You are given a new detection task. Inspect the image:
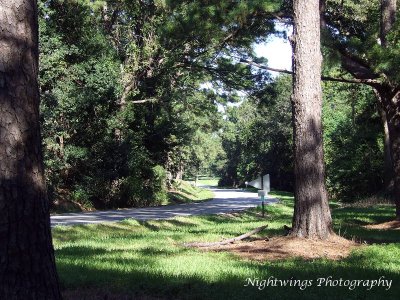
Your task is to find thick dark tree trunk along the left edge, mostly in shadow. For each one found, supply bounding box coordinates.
[0,0,61,299]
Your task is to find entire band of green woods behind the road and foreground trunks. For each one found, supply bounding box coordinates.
[39,0,399,211]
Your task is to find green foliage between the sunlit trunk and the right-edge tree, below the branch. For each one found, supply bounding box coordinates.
[323,83,383,201]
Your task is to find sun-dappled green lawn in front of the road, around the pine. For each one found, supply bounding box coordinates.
[53,193,400,300]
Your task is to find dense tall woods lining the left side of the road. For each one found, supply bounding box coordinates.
[40,0,278,207]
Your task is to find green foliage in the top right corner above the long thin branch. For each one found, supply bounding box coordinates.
[324,0,400,84]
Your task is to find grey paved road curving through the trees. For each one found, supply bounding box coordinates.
[51,188,277,226]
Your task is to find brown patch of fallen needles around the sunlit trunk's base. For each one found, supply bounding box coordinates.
[207,236,361,261]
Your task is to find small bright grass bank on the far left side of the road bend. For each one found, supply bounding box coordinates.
[163,180,214,205]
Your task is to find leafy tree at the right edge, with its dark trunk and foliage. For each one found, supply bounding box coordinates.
[323,0,400,218]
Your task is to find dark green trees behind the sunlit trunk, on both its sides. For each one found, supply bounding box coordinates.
[221,75,385,201]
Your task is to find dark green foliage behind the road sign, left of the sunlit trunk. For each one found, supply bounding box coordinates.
[220,76,293,190]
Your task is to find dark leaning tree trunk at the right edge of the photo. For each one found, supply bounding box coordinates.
[376,86,400,220]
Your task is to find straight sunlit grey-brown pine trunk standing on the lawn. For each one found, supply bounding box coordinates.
[292,0,332,239]
